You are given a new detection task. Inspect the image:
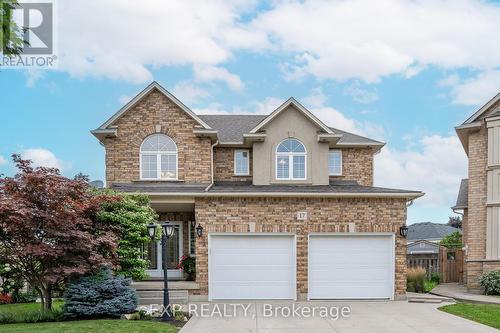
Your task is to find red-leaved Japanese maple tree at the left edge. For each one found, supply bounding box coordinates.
[0,155,119,309]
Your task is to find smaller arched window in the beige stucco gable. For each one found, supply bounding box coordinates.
[276,139,307,180]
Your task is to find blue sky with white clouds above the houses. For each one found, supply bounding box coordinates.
[0,0,500,224]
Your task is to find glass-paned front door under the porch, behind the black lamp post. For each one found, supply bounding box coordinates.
[147,222,183,280]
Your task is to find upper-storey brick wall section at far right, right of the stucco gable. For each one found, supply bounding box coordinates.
[330,148,374,186]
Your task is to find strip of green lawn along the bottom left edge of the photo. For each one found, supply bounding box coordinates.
[0,320,178,333]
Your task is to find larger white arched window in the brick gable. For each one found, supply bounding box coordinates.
[141,134,177,180]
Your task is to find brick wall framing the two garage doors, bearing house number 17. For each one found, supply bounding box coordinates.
[195,198,406,295]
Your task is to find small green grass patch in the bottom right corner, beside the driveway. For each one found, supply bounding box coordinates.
[439,303,500,329]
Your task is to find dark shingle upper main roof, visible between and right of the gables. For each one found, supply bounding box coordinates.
[199,115,382,144]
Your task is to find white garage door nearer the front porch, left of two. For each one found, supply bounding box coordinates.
[208,234,296,300]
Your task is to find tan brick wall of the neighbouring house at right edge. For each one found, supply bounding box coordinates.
[463,121,500,289]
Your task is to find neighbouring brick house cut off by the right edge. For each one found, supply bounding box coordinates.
[452,93,500,289]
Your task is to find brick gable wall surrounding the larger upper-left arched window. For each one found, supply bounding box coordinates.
[104,90,211,186]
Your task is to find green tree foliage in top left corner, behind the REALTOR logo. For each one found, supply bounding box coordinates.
[0,0,28,56]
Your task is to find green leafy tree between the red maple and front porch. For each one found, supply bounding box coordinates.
[92,189,158,281]
